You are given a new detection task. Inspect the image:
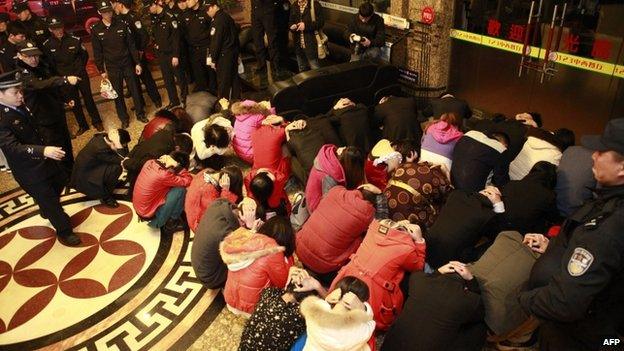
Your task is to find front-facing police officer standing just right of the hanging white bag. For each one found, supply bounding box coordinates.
[91,0,148,128]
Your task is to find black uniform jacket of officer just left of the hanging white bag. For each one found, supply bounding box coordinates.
[43,34,89,76]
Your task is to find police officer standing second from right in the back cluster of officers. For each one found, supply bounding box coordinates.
[180,0,217,93]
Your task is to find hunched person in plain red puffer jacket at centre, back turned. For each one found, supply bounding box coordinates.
[296,185,379,280]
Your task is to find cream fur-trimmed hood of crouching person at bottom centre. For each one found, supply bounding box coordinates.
[300,296,375,351]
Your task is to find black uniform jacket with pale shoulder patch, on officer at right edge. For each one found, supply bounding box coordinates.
[519,186,624,348]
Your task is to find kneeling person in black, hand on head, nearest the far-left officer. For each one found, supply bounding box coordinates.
[70,129,130,208]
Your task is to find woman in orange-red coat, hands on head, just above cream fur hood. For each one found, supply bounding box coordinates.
[332,219,426,330]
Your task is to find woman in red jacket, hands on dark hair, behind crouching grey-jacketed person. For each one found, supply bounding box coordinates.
[184,166,243,232]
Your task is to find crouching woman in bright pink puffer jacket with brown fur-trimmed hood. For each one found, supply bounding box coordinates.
[230,100,275,163]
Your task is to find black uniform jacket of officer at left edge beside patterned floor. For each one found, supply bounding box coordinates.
[0,105,57,184]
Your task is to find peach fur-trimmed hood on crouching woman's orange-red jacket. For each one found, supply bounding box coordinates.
[219,227,286,271]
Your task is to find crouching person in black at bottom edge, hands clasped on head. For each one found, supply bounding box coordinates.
[380,261,487,351]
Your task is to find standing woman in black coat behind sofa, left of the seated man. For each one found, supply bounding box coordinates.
[288,0,324,72]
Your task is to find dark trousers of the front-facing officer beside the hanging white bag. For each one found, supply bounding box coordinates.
[106,64,145,122]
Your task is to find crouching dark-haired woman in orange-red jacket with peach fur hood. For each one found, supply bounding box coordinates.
[219,216,295,317]
